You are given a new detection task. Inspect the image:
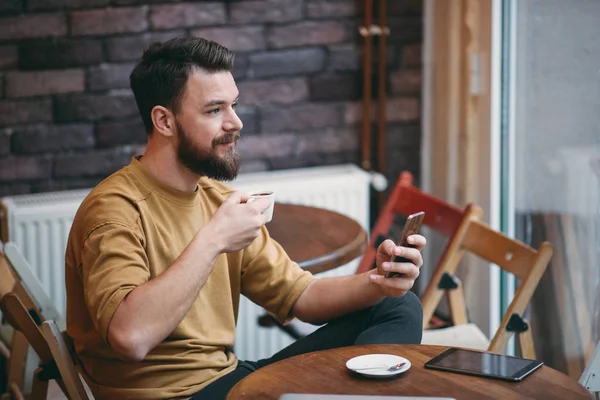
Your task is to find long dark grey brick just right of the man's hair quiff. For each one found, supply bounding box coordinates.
[248,47,326,78]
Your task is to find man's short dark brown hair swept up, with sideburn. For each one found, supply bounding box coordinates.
[129,37,234,134]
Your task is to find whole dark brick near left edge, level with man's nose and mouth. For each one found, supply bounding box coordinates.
[12,124,94,154]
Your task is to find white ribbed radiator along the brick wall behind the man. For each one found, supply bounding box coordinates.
[0,165,371,360]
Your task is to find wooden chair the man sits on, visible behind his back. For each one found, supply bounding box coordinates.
[0,293,90,400]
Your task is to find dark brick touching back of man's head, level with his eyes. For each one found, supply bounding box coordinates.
[55,91,138,122]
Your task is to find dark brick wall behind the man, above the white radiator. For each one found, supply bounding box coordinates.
[0,0,422,196]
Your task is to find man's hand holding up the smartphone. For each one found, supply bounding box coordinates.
[370,235,427,297]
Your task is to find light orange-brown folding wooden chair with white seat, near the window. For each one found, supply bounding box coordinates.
[422,219,553,359]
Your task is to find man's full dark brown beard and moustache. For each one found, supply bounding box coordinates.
[175,122,240,181]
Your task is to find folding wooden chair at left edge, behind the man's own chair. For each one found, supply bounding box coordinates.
[0,242,59,398]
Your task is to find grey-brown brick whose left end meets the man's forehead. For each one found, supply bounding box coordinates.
[238,78,308,106]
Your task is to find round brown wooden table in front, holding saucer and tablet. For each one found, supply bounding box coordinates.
[227,345,592,400]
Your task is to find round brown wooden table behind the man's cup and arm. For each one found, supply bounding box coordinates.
[267,203,367,274]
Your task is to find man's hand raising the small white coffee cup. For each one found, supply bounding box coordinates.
[207,192,271,253]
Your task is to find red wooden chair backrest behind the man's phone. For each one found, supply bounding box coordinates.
[357,171,474,276]
